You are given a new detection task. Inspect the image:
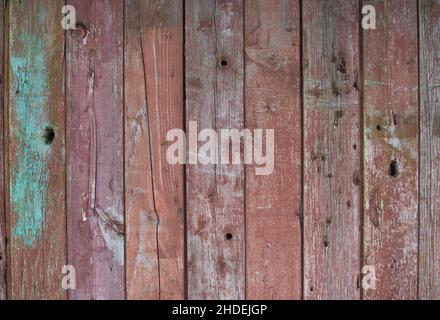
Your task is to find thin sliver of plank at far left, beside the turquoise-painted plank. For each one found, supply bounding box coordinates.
[0,0,7,300]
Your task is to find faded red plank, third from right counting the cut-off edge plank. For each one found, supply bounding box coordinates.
[303,0,361,300]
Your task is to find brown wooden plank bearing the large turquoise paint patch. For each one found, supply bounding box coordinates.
[7,0,66,299]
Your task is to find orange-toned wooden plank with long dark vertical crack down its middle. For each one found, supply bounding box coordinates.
[125,0,185,299]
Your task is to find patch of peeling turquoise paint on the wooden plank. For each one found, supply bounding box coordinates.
[10,34,50,247]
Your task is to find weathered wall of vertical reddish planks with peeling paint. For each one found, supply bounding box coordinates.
[0,0,440,300]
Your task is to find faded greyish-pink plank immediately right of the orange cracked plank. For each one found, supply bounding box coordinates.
[185,0,245,299]
